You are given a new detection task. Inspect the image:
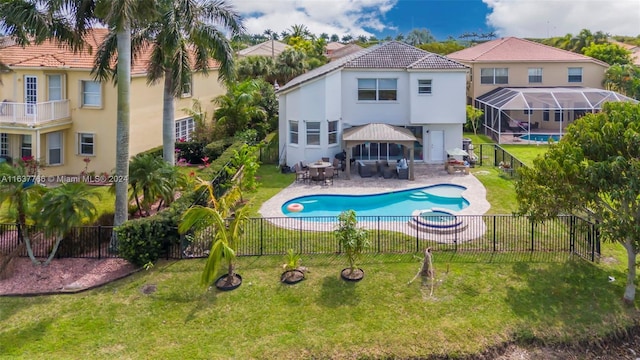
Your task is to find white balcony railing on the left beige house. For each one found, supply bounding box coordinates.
[0,100,70,126]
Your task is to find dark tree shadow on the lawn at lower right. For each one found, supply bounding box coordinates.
[506,259,628,342]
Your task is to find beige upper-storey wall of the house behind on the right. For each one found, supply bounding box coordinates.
[458,60,607,103]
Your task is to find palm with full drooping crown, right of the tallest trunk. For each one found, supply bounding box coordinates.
[94,0,244,165]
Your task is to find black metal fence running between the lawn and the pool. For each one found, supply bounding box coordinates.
[0,215,600,261]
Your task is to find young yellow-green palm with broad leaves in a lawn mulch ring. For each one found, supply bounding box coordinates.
[178,179,247,286]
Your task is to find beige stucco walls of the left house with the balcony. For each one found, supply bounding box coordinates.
[0,69,225,175]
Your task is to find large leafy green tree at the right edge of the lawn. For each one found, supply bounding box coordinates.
[516,102,640,302]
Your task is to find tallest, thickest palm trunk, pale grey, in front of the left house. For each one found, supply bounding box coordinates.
[109,24,131,250]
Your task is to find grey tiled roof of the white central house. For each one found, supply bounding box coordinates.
[278,41,467,93]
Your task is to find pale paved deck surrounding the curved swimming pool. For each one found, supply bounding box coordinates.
[259,164,491,242]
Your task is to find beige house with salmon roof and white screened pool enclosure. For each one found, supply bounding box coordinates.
[447,37,633,142]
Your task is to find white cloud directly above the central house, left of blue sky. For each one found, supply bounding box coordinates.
[233,0,398,36]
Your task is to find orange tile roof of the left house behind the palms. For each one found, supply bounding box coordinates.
[0,28,215,75]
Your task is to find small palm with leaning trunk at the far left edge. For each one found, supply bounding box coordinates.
[0,160,44,264]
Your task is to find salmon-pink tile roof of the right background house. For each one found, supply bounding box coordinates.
[447,37,609,67]
